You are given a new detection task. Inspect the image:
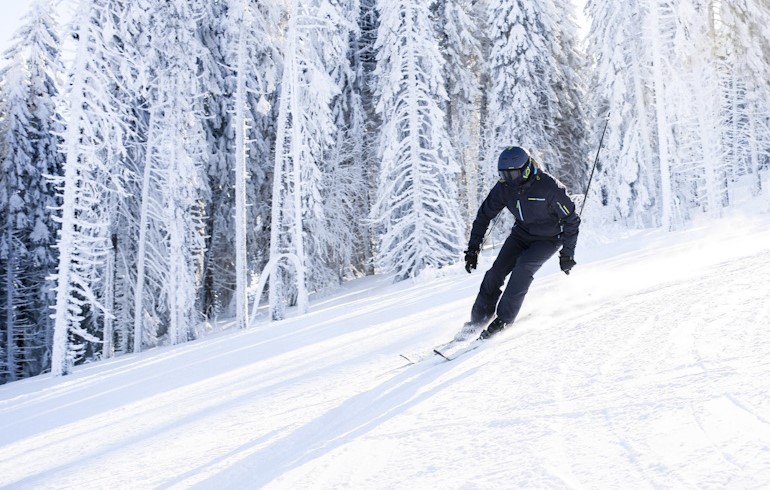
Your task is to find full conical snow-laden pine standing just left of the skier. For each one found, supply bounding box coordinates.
[371,0,463,280]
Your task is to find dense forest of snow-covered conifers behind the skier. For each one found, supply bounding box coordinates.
[0,0,770,383]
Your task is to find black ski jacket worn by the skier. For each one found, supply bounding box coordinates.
[468,167,580,257]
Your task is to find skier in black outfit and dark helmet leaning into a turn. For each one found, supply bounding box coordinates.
[455,146,580,341]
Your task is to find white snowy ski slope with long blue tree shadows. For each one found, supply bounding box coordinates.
[0,205,770,489]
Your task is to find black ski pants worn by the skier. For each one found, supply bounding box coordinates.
[471,227,561,324]
